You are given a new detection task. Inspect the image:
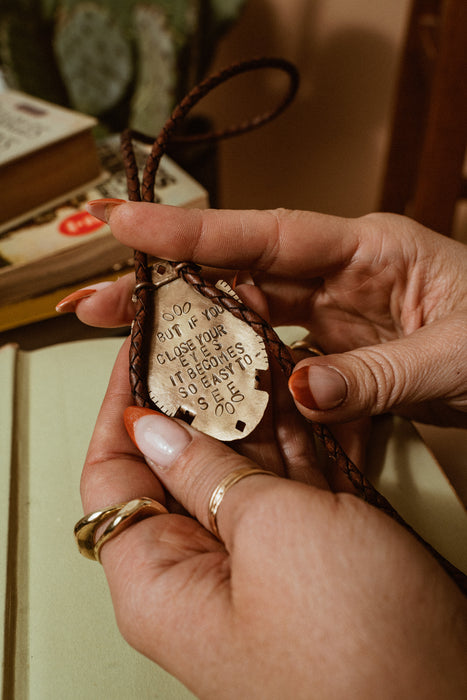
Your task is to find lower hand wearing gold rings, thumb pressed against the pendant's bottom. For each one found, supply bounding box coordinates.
[82,343,467,700]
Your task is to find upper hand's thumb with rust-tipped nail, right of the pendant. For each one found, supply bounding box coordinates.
[289,319,467,422]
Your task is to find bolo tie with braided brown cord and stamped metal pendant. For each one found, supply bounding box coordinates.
[121,58,467,594]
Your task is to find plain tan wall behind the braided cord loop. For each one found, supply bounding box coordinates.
[201,0,409,216]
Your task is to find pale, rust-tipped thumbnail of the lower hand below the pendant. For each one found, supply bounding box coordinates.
[123,406,191,471]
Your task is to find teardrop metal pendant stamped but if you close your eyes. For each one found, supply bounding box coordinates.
[147,260,269,441]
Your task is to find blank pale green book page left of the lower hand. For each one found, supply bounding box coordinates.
[15,338,192,700]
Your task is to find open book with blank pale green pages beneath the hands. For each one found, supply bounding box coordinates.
[0,338,467,700]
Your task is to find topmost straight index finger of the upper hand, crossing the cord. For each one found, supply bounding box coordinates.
[86,199,359,278]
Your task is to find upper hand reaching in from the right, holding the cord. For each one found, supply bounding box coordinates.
[78,200,467,426]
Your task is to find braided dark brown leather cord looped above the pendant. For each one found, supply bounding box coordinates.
[121,58,467,594]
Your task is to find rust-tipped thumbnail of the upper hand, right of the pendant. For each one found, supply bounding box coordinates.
[289,365,347,411]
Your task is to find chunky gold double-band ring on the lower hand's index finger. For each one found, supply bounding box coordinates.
[74,497,169,562]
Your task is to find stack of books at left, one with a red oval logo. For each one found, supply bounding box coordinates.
[0,91,208,331]
